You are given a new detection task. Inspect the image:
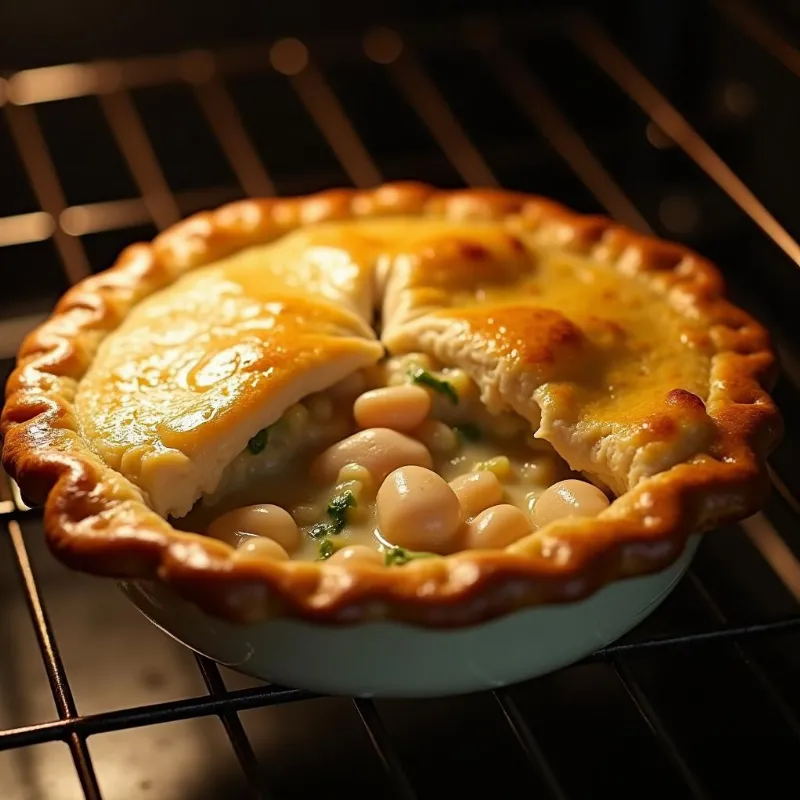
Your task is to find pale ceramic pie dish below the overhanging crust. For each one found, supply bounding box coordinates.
[120,536,700,697]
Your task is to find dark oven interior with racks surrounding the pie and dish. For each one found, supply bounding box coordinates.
[0,0,800,800]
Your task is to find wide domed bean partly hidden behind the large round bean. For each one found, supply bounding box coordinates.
[311,428,433,484]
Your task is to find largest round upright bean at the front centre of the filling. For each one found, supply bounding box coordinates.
[376,466,464,553]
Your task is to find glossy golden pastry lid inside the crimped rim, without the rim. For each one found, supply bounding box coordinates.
[75,215,714,517]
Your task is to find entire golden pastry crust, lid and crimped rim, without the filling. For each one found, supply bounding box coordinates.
[2,184,780,626]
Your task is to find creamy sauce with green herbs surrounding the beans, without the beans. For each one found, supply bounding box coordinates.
[181,354,575,560]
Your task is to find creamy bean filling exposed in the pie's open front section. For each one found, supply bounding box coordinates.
[179,354,609,566]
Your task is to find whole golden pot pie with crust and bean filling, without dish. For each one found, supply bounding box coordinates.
[2,184,780,626]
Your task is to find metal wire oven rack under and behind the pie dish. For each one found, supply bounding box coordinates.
[0,0,800,800]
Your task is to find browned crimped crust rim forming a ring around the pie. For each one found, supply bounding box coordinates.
[0,183,782,627]
